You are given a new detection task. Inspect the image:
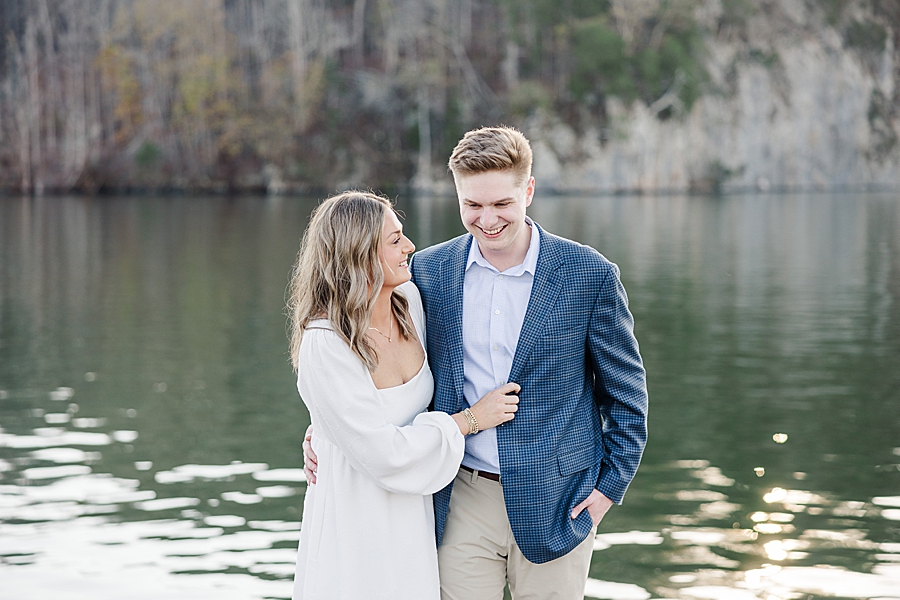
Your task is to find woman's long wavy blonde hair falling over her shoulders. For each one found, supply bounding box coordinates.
[287,190,416,372]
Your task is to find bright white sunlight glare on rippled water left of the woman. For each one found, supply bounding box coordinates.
[0,454,299,599]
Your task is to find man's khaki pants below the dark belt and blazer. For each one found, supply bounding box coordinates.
[438,469,594,600]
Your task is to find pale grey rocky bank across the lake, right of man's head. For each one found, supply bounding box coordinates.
[524,0,900,193]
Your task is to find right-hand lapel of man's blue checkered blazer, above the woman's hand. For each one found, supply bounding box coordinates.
[509,227,562,381]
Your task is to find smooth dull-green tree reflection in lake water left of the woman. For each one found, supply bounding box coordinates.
[0,198,311,478]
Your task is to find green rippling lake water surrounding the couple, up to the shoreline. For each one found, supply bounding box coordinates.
[0,194,900,600]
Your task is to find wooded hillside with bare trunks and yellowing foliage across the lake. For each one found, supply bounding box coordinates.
[0,0,880,193]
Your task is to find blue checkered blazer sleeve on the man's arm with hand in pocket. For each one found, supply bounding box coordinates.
[587,263,648,504]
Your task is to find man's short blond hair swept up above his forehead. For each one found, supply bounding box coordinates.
[448,125,531,185]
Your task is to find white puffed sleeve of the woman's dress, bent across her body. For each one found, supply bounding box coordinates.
[297,329,465,494]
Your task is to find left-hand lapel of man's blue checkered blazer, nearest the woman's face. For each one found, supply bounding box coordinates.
[440,235,472,410]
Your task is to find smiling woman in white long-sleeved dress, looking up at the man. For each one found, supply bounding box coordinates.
[289,191,518,600]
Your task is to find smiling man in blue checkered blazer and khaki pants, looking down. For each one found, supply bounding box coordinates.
[304,127,647,600]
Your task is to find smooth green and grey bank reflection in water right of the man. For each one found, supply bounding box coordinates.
[568,195,900,498]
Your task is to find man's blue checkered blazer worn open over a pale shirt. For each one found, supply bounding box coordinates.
[412,223,647,563]
